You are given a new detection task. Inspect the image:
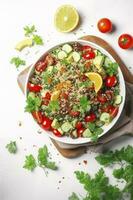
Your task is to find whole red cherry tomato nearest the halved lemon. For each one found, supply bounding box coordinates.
[97,18,112,33]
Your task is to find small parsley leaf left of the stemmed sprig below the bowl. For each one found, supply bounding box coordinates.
[23,154,37,171]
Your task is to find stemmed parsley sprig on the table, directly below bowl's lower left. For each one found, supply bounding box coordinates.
[38,145,57,170]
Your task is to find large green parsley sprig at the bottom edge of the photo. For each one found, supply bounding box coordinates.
[73,168,122,200]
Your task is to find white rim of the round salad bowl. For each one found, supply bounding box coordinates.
[24,39,126,145]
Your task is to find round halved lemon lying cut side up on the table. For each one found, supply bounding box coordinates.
[54,5,79,32]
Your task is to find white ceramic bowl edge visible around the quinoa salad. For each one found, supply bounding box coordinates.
[25,40,125,145]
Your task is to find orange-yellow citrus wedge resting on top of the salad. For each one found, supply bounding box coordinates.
[85,72,103,93]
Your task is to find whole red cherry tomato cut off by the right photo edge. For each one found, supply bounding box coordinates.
[118,34,133,49]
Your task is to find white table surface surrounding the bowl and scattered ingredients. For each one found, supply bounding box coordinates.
[0,0,133,200]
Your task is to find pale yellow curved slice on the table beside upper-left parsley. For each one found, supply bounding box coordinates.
[15,38,33,51]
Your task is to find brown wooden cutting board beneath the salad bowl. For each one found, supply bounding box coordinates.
[18,35,133,158]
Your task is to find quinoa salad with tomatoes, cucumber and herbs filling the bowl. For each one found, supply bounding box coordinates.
[25,42,122,141]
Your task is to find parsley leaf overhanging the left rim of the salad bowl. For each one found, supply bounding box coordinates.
[25,96,41,112]
